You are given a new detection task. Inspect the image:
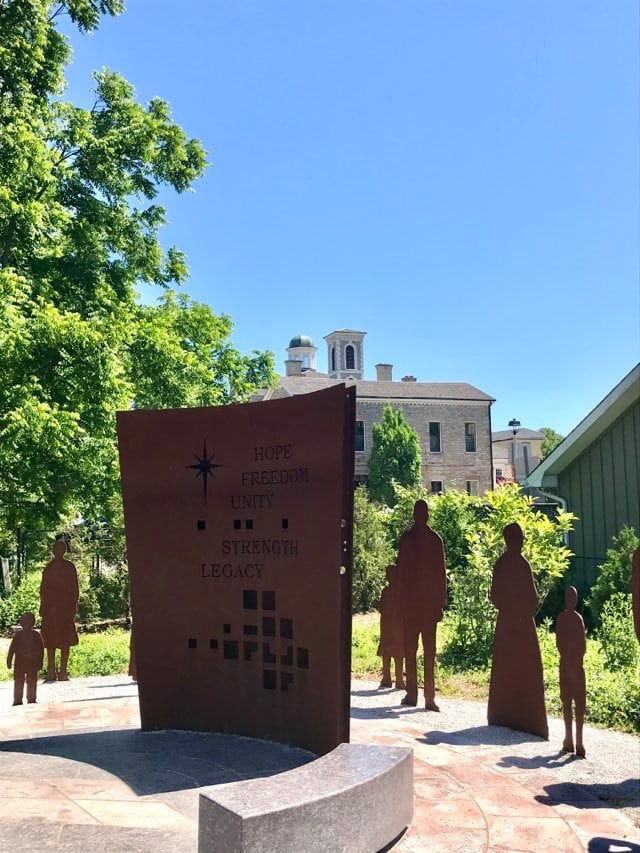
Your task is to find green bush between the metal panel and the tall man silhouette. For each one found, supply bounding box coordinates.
[353,486,393,613]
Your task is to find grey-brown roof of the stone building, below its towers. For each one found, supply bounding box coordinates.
[260,373,494,403]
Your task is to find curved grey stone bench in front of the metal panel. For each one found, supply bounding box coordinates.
[198,743,413,853]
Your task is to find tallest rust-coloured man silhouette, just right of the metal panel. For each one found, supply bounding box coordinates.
[397,500,447,711]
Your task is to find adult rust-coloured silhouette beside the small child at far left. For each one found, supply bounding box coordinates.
[40,539,80,681]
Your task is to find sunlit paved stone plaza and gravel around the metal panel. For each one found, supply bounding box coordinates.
[0,676,640,853]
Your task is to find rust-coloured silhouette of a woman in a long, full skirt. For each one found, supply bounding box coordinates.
[487,523,549,739]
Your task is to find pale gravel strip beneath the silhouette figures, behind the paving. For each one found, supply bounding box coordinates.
[0,675,640,825]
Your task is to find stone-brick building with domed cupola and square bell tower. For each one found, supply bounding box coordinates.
[254,329,494,494]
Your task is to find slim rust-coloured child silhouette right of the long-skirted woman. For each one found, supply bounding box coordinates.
[556,586,587,758]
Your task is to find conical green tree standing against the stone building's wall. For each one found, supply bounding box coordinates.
[369,403,422,506]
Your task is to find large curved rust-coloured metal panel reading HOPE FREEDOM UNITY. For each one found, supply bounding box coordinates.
[118,385,355,754]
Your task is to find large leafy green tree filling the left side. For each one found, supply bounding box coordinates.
[0,0,273,553]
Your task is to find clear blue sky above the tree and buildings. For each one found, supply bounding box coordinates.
[61,0,640,433]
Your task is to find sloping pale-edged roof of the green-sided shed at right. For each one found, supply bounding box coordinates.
[526,364,640,488]
